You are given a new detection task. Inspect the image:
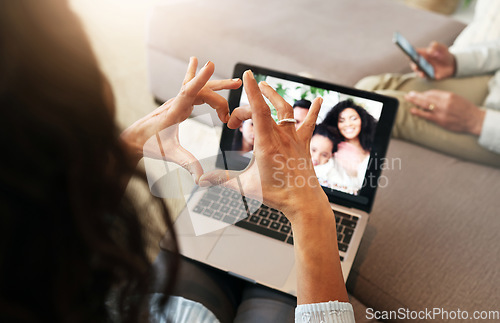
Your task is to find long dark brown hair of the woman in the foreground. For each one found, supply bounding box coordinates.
[0,0,177,322]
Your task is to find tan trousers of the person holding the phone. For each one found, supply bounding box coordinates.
[355,73,500,167]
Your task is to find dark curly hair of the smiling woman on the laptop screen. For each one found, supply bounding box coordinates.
[321,99,377,151]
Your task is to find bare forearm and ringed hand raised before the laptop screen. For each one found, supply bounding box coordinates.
[200,71,352,308]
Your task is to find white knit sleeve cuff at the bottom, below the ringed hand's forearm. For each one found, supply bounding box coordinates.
[295,301,354,323]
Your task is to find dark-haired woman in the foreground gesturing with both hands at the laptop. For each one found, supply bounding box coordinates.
[0,0,353,323]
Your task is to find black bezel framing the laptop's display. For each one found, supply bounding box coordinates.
[216,63,398,213]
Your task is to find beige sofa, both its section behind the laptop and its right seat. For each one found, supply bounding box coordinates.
[147,0,500,322]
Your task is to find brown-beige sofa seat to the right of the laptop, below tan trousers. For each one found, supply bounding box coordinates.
[347,140,500,322]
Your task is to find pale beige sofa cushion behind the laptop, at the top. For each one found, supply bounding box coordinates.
[147,0,464,100]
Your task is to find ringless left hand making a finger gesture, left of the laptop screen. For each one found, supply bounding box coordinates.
[121,57,241,182]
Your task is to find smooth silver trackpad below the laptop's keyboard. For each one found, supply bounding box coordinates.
[208,226,295,288]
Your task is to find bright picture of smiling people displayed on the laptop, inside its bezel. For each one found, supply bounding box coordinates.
[231,74,383,195]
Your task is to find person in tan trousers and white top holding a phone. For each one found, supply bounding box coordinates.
[355,6,500,167]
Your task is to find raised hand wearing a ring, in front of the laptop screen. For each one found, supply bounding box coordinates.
[200,71,327,222]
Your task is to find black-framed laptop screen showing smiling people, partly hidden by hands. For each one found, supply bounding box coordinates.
[217,64,397,212]
